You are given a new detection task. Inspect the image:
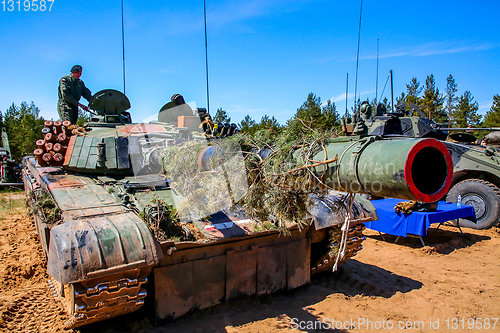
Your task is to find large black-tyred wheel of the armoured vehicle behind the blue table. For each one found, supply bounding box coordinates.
[446,179,500,229]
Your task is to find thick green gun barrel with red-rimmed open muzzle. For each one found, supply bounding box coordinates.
[198,137,453,202]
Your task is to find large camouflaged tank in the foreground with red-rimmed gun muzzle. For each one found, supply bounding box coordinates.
[23,90,451,327]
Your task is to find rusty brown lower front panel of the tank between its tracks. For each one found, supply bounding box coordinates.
[154,224,310,322]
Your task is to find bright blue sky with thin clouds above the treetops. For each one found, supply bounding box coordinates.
[0,0,500,124]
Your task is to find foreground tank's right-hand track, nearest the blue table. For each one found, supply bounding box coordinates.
[311,224,366,274]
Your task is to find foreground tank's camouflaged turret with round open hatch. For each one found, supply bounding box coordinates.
[51,89,224,176]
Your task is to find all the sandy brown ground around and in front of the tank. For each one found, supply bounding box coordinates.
[0,195,500,333]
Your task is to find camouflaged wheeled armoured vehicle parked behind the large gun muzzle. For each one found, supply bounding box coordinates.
[343,102,500,229]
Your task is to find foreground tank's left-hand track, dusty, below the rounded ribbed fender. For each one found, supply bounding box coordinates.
[49,270,148,329]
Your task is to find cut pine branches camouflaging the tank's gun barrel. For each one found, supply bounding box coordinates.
[160,120,344,233]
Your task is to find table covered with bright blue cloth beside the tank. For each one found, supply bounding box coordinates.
[365,199,476,243]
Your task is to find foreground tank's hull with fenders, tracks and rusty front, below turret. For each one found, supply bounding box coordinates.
[23,158,377,328]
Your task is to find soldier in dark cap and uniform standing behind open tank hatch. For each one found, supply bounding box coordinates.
[57,65,92,124]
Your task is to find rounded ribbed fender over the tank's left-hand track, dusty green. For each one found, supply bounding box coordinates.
[47,212,163,284]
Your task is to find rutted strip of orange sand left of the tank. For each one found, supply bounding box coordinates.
[0,193,70,332]
